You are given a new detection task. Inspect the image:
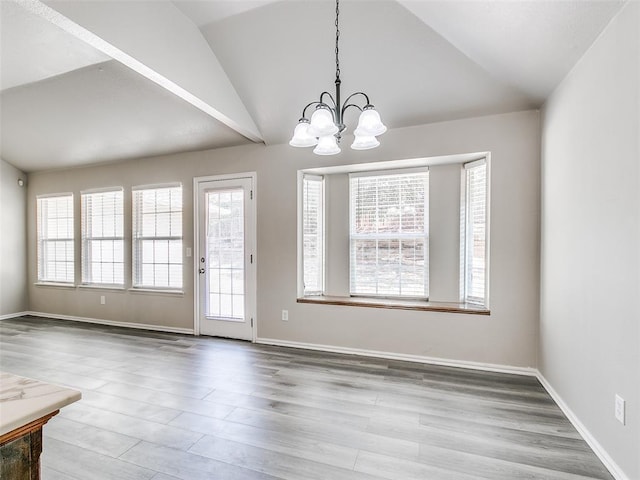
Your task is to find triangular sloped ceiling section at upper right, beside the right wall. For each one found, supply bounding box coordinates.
[400,0,623,103]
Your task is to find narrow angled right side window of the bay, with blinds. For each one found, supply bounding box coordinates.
[460,159,488,305]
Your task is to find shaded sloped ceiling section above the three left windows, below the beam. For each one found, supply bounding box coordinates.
[1,60,248,171]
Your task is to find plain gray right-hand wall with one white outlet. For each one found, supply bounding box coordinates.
[539,2,640,479]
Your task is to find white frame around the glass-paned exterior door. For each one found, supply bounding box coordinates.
[193,172,258,343]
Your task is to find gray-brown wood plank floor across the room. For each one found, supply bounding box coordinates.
[0,317,613,480]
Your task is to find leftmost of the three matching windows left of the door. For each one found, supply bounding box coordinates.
[36,193,74,283]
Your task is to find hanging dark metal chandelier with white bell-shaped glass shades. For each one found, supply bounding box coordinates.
[289,0,387,155]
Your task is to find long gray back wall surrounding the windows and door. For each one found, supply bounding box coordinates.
[28,111,540,367]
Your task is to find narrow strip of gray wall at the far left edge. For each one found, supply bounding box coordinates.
[0,159,28,317]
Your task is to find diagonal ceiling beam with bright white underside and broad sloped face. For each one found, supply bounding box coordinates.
[14,0,263,142]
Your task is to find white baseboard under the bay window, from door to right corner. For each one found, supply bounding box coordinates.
[256,338,538,376]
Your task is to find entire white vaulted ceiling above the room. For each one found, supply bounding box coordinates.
[0,0,623,171]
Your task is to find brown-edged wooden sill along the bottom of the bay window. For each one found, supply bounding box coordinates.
[297,295,491,315]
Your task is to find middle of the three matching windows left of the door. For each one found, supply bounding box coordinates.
[81,189,124,285]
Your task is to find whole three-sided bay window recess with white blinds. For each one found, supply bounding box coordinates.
[296,158,491,315]
